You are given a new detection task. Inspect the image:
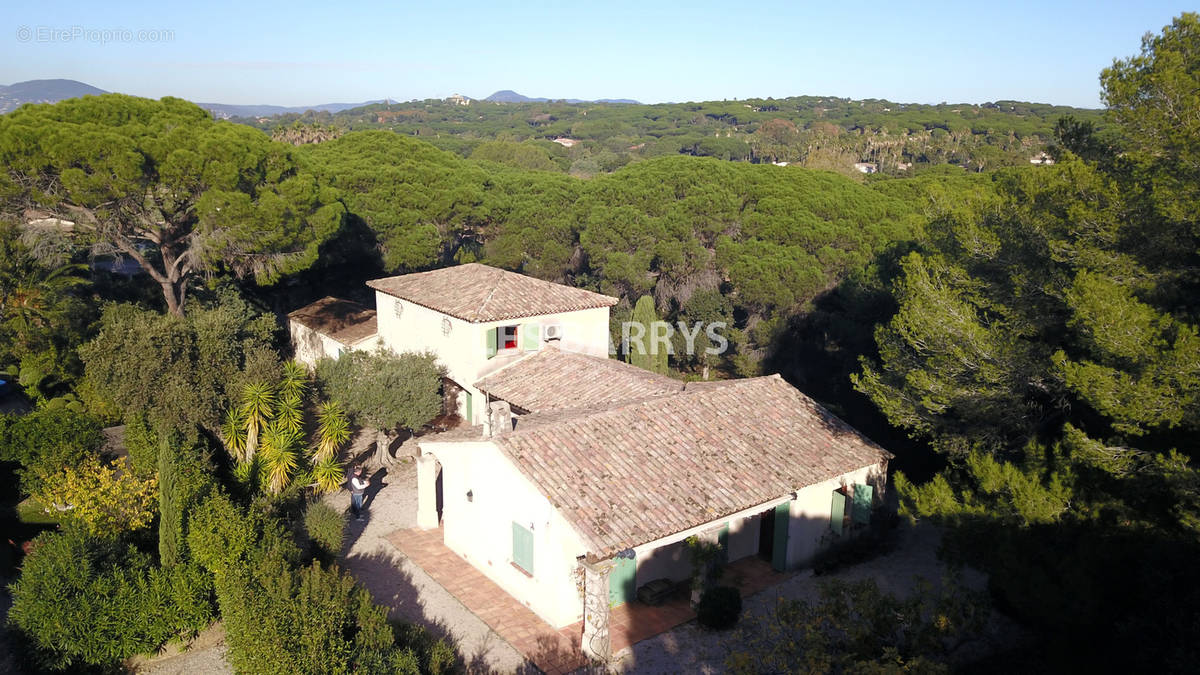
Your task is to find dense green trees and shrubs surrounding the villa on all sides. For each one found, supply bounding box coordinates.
[0,13,1200,673]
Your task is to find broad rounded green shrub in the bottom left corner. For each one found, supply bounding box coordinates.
[8,528,212,670]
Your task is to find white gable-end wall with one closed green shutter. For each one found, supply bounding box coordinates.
[421,441,584,627]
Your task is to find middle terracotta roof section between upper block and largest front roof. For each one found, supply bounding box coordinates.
[475,344,683,412]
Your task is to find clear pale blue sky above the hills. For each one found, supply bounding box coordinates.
[0,0,1188,107]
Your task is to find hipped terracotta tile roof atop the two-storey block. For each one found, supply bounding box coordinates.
[367,263,617,323]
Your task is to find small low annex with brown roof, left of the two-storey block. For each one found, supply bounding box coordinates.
[288,297,377,368]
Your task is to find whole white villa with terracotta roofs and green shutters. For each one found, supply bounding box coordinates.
[293,264,892,658]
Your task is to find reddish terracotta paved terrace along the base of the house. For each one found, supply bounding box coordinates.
[386,527,790,675]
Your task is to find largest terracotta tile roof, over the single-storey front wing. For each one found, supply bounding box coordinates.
[482,375,892,558]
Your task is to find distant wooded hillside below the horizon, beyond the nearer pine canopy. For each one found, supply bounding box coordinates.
[234,96,1104,177]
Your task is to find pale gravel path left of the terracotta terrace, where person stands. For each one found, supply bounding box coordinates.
[326,450,526,673]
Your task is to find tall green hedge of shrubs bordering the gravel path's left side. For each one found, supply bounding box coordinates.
[187,494,456,674]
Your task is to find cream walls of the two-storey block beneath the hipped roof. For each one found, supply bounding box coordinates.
[376,291,608,424]
